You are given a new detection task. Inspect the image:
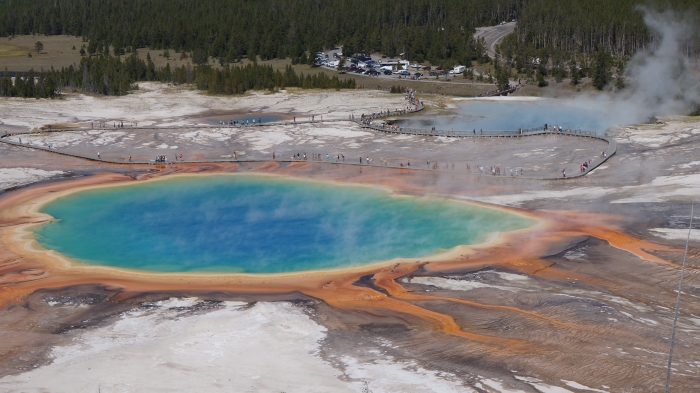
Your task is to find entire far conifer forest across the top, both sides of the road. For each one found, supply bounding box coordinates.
[0,0,700,64]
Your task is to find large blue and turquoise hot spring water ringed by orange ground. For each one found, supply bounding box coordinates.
[36,175,532,273]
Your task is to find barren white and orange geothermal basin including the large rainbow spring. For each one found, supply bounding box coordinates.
[0,49,700,393]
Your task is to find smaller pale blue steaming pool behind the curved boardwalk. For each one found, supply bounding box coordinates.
[409,99,615,133]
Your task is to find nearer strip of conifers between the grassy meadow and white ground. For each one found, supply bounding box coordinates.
[0,52,356,98]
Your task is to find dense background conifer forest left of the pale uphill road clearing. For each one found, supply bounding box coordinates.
[0,0,523,64]
